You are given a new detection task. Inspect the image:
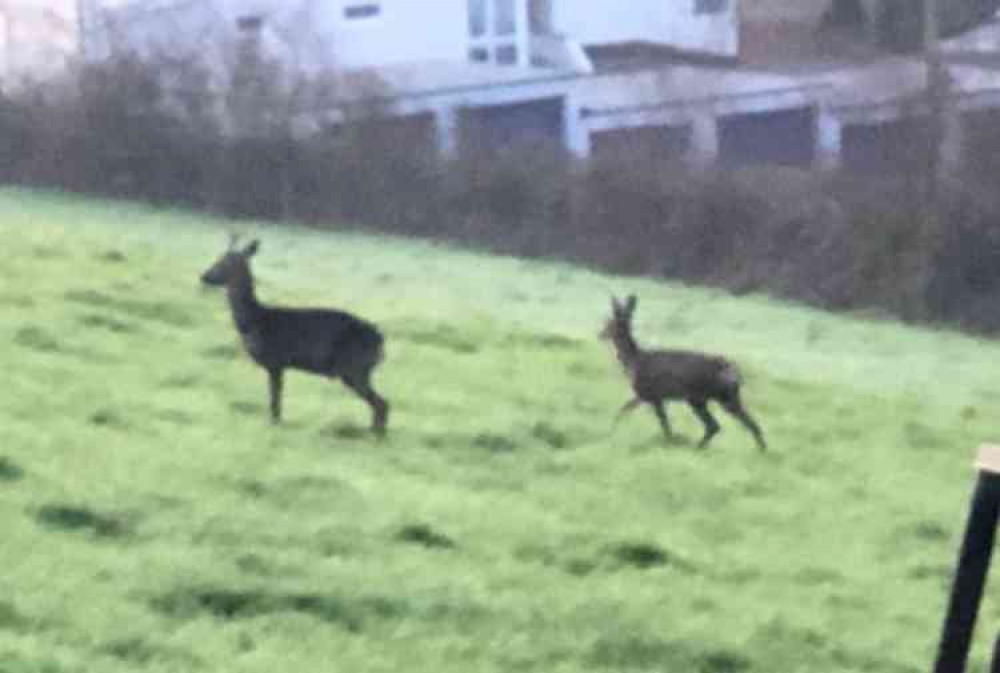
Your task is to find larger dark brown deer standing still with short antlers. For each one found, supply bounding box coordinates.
[201,237,389,436]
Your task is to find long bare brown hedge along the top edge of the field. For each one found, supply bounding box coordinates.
[0,28,1000,332]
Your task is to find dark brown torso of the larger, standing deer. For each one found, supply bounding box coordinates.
[241,307,383,376]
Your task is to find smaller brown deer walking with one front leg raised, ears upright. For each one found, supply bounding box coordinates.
[601,295,767,451]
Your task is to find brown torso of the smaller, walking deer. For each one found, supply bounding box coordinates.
[632,350,740,400]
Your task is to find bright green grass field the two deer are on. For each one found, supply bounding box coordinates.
[0,185,1000,673]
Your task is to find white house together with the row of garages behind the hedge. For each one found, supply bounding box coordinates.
[87,0,1000,173]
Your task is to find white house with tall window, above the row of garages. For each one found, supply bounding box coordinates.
[92,0,739,71]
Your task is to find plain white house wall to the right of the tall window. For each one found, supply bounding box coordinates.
[552,0,739,56]
